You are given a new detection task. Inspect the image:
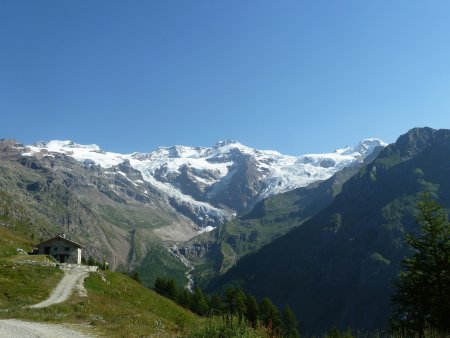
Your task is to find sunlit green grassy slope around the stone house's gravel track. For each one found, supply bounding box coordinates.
[0,228,200,337]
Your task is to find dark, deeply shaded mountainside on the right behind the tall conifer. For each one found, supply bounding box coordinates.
[210,128,450,333]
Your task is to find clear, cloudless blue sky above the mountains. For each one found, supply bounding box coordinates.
[0,0,450,155]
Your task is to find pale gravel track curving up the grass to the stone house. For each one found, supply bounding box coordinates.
[29,271,88,308]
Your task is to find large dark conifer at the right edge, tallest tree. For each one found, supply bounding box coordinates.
[391,194,450,334]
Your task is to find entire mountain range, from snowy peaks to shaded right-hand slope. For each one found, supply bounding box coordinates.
[0,128,450,334]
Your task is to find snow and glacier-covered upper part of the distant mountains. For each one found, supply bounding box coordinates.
[22,138,386,227]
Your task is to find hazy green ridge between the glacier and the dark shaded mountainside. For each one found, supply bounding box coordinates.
[187,164,358,285]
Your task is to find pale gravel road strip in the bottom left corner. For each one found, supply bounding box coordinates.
[0,319,89,338]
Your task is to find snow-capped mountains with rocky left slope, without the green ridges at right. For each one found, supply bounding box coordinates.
[0,139,384,285]
